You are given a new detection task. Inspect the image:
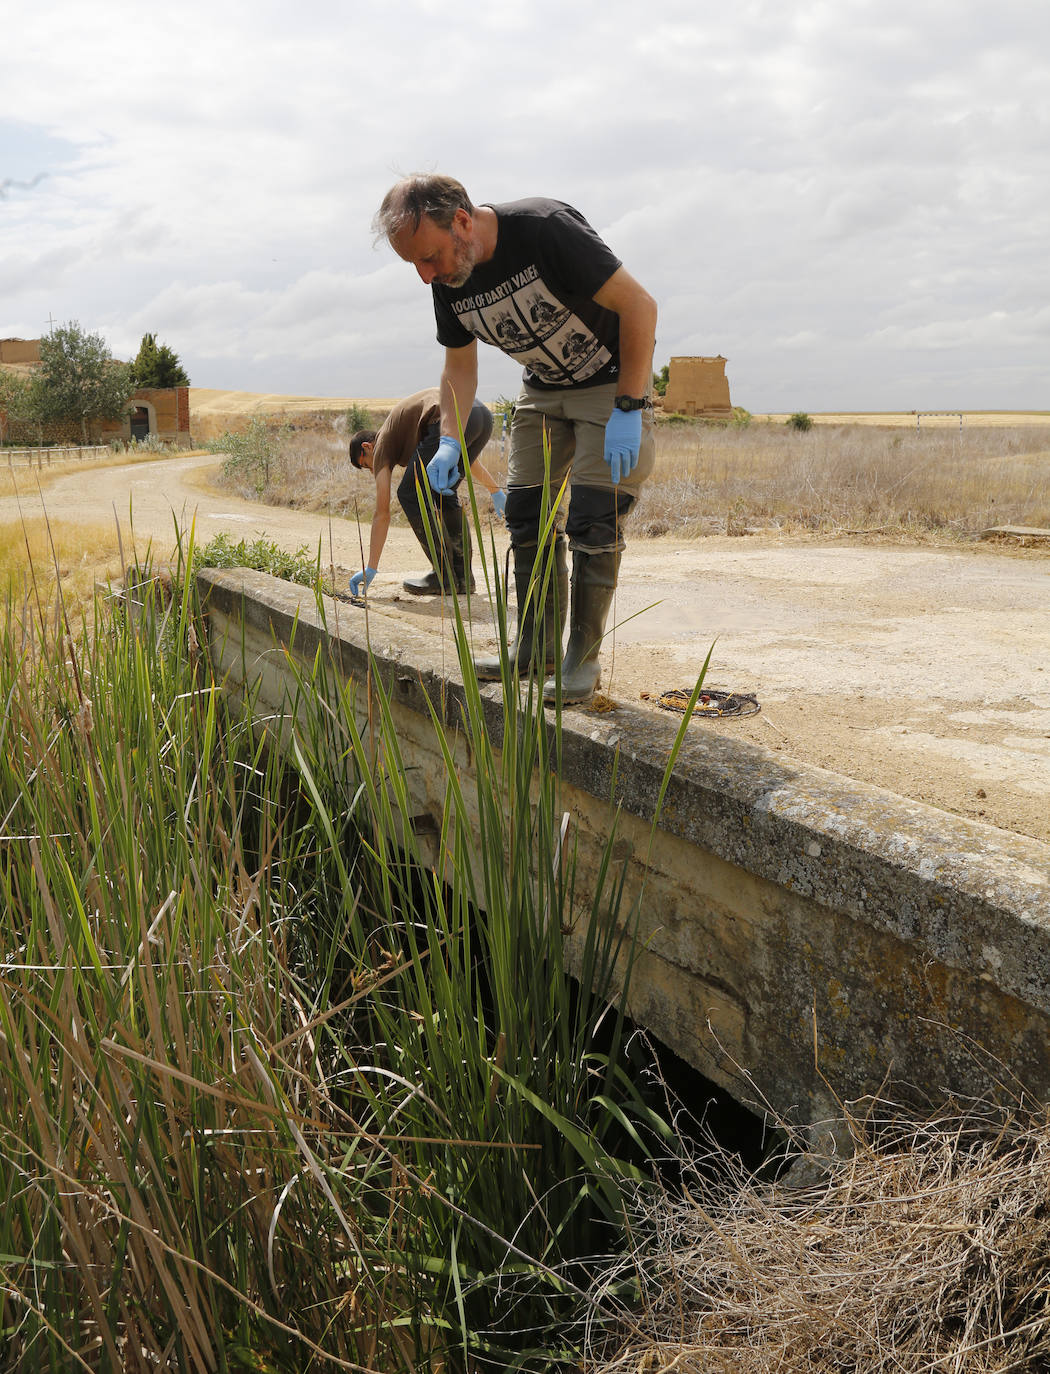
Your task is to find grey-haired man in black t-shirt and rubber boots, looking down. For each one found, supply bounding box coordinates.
[374,176,657,702]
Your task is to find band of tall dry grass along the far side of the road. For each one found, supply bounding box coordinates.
[211,416,1050,543]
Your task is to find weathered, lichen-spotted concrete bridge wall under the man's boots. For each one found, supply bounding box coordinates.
[201,570,1050,1121]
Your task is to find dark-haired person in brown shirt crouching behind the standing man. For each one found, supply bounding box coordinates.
[350,387,506,596]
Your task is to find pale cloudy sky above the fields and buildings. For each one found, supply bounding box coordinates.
[0,0,1050,411]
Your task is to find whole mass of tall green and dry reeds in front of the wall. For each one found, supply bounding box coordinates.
[0,456,703,1371]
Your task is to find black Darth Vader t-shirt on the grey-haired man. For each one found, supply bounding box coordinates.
[432,199,621,390]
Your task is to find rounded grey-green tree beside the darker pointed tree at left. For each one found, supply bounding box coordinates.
[32,320,135,444]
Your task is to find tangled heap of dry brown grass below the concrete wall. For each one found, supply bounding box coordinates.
[588,1093,1050,1374]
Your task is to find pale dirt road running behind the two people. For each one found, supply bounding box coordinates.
[10,456,1050,841]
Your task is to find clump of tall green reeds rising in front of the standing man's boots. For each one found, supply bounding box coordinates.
[270,450,709,1369]
